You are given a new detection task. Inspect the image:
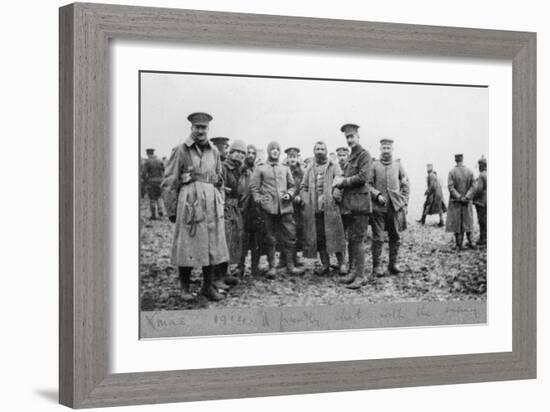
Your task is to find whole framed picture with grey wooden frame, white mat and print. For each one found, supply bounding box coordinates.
[60,3,536,408]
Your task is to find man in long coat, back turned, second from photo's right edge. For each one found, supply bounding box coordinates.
[446,154,474,250]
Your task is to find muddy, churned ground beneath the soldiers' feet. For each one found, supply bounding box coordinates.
[140,201,487,310]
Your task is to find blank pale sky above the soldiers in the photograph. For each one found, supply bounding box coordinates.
[141,73,489,219]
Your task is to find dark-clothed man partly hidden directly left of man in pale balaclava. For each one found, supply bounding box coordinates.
[239,145,265,276]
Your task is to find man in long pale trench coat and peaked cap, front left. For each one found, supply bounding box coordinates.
[162,112,229,301]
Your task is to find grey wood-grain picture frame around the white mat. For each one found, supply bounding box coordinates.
[59,3,536,408]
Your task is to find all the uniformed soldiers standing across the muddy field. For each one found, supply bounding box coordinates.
[142,112,487,301]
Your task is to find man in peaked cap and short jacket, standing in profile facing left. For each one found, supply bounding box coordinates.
[333,123,372,289]
